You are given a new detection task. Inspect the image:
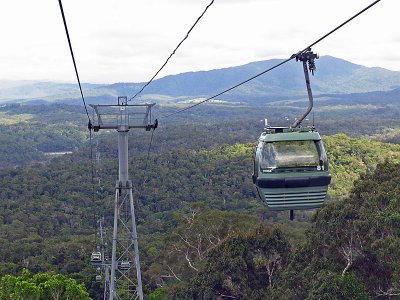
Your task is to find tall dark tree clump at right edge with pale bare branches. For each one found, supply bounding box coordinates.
[287,161,400,299]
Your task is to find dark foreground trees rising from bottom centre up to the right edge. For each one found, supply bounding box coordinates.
[174,162,400,300]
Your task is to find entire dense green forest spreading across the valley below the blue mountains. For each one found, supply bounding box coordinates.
[0,104,400,299]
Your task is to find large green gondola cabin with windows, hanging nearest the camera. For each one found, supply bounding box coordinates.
[253,127,331,211]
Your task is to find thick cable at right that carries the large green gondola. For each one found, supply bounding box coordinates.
[164,0,381,118]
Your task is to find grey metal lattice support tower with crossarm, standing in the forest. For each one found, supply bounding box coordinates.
[91,97,157,300]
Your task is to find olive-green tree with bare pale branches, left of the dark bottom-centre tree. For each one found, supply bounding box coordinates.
[148,209,259,286]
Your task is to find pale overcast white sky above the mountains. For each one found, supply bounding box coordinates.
[0,0,400,83]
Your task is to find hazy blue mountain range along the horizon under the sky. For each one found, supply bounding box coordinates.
[0,56,400,104]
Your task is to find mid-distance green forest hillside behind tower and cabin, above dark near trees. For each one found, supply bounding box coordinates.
[0,129,398,298]
